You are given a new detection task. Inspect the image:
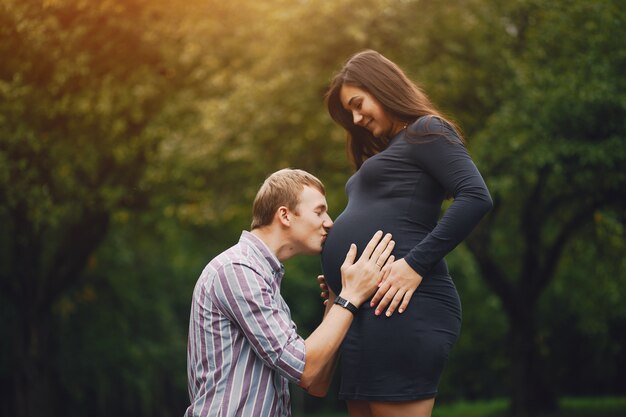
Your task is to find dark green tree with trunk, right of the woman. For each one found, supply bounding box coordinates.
[469,1,626,415]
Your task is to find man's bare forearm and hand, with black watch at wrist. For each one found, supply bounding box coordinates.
[300,232,394,396]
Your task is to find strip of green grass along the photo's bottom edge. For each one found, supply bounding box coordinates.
[294,397,626,417]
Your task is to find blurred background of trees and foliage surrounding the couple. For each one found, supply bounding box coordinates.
[0,0,626,417]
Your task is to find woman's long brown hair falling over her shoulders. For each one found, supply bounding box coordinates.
[325,50,462,169]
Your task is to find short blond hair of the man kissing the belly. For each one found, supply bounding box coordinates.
[250,168,326,230]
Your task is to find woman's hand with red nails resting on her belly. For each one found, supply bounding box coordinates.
[370,259,422,317]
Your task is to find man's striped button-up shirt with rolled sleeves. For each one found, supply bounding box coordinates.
[185,231,305,417]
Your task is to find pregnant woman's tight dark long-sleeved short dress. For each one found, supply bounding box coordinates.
[322,116,492,401]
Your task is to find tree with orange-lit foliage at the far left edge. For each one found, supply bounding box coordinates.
[0,0,197,417]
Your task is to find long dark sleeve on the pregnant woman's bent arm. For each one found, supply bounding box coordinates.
[404,116,493,276]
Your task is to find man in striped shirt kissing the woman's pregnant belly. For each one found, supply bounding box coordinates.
[185,169,394,417]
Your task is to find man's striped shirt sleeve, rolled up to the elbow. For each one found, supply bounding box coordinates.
[214,263,305,384]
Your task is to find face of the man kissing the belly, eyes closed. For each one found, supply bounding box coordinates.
[290,187,333,255]
